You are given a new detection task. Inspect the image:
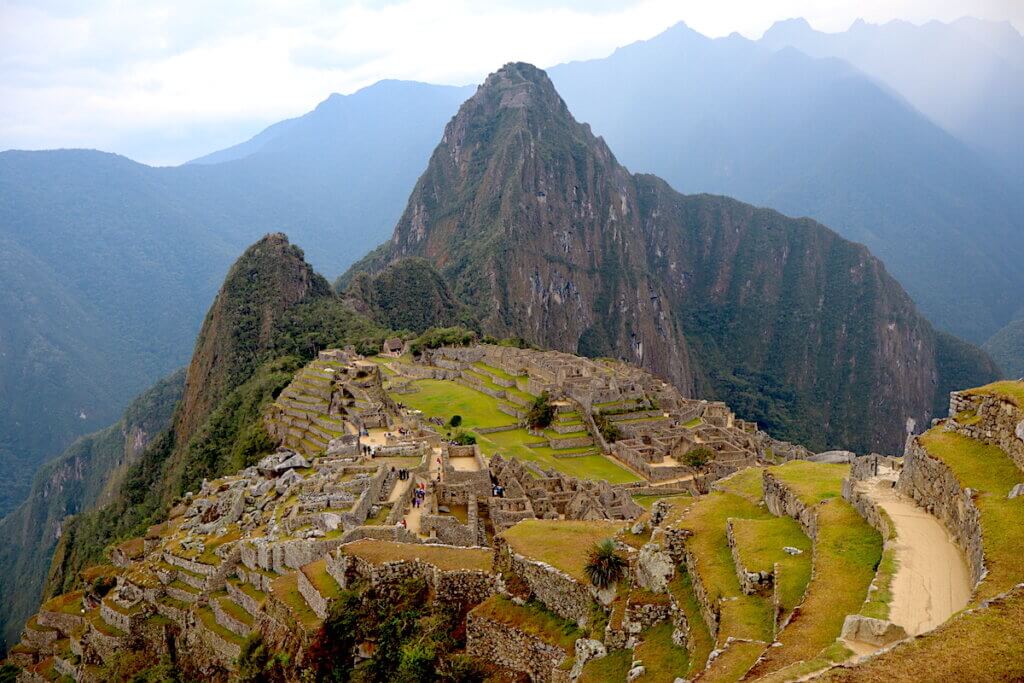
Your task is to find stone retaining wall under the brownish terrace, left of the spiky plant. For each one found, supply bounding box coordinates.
[495,537,594,627]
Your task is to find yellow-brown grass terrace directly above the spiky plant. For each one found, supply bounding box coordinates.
[501,519,626,586]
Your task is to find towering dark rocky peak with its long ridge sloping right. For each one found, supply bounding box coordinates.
[355,63,987,451]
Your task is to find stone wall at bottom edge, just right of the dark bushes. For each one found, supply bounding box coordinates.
[466,612,567,682]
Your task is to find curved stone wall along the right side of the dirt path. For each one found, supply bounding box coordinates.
[896,437,985,586]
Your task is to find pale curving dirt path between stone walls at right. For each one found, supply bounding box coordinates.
[863,478,971,636]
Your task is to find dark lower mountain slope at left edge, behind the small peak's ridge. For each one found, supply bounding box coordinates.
[0,371,184,651]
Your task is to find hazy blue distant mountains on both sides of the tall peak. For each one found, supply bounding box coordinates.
[0,15,1024,513]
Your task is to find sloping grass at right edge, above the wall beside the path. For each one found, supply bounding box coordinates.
[920,429,1024,602]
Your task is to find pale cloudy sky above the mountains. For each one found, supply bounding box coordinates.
[0,0,1024,164]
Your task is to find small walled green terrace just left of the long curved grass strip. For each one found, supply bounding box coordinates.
[732,517,811,612]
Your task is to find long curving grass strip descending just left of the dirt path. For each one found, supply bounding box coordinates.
[755,498,882,674]
